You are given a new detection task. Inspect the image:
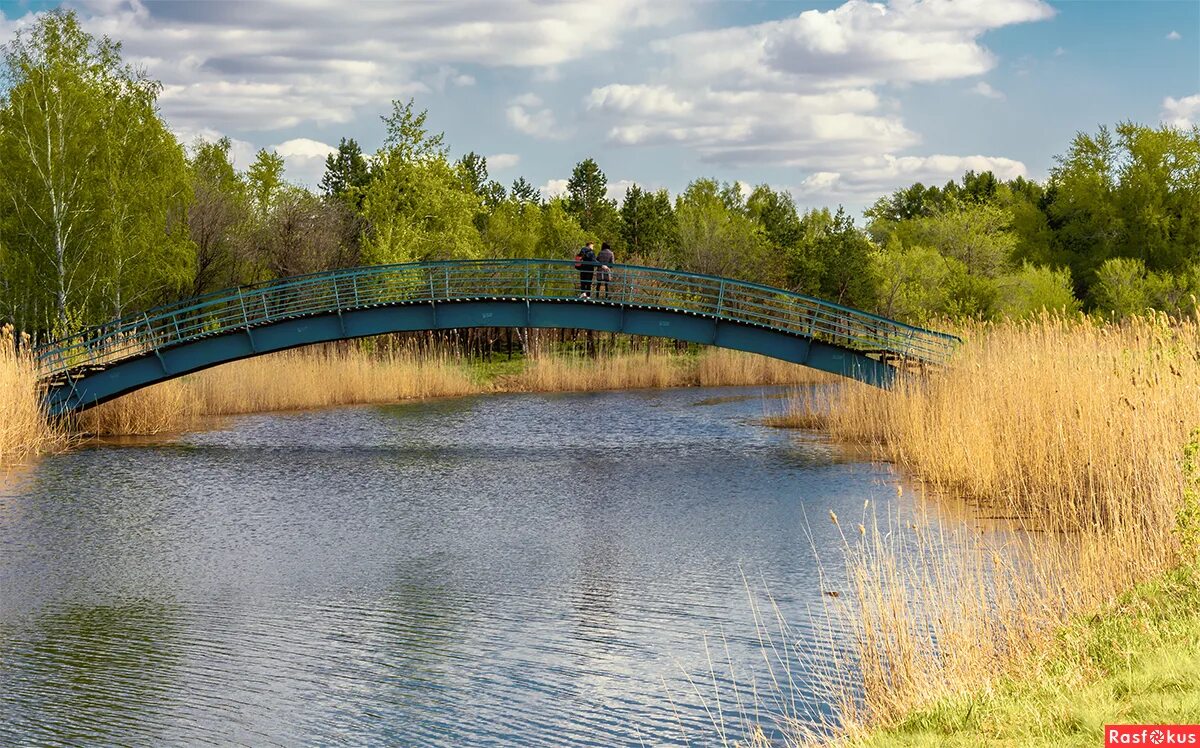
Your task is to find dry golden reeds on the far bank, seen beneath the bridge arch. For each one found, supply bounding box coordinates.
[77,346,821,436]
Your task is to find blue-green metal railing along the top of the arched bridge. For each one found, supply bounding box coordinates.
[36,259,960,377]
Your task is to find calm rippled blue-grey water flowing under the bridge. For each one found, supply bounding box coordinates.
[0,389,921,746]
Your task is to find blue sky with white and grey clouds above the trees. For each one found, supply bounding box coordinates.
[0,0,1200,210]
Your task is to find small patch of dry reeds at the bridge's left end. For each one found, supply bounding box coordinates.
[0,325,64,465]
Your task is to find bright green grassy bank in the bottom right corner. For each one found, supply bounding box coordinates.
[856,568,1200,748]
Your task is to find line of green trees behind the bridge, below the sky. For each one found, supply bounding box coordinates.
[0,11,1200,335]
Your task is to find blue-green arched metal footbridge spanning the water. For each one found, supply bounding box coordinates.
[36,259,959,415]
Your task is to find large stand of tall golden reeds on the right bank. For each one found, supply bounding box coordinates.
[772,316,1200,734]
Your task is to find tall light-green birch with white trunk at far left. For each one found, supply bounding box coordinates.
[0,10,191,331]
